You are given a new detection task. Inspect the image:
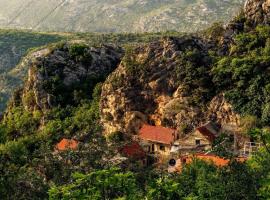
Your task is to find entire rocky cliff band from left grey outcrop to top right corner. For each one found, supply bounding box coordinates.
[5,0,269,138]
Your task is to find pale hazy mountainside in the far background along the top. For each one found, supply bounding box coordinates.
[0,0,244,32]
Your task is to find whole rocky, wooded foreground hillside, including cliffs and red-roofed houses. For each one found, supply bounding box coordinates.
[0,0,270,200]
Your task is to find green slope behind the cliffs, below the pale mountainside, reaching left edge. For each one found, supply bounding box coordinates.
[0,30,187,111]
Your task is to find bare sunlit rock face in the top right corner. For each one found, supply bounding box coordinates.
[244,0,270,25]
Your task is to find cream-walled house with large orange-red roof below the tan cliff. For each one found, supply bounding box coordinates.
[138,124,179,155]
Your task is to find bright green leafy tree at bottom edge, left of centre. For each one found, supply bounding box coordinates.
[49,168,142,200]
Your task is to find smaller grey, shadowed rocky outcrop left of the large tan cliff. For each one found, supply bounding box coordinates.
[11,42,123,110]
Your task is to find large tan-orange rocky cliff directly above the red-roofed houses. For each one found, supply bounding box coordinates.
[100,37,239,134]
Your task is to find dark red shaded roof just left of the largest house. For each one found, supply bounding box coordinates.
[120,142,146,159]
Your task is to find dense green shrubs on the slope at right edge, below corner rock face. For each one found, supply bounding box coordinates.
[212,26,270,124]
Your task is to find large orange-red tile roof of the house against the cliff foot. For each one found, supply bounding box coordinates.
[139,124,176,144]
